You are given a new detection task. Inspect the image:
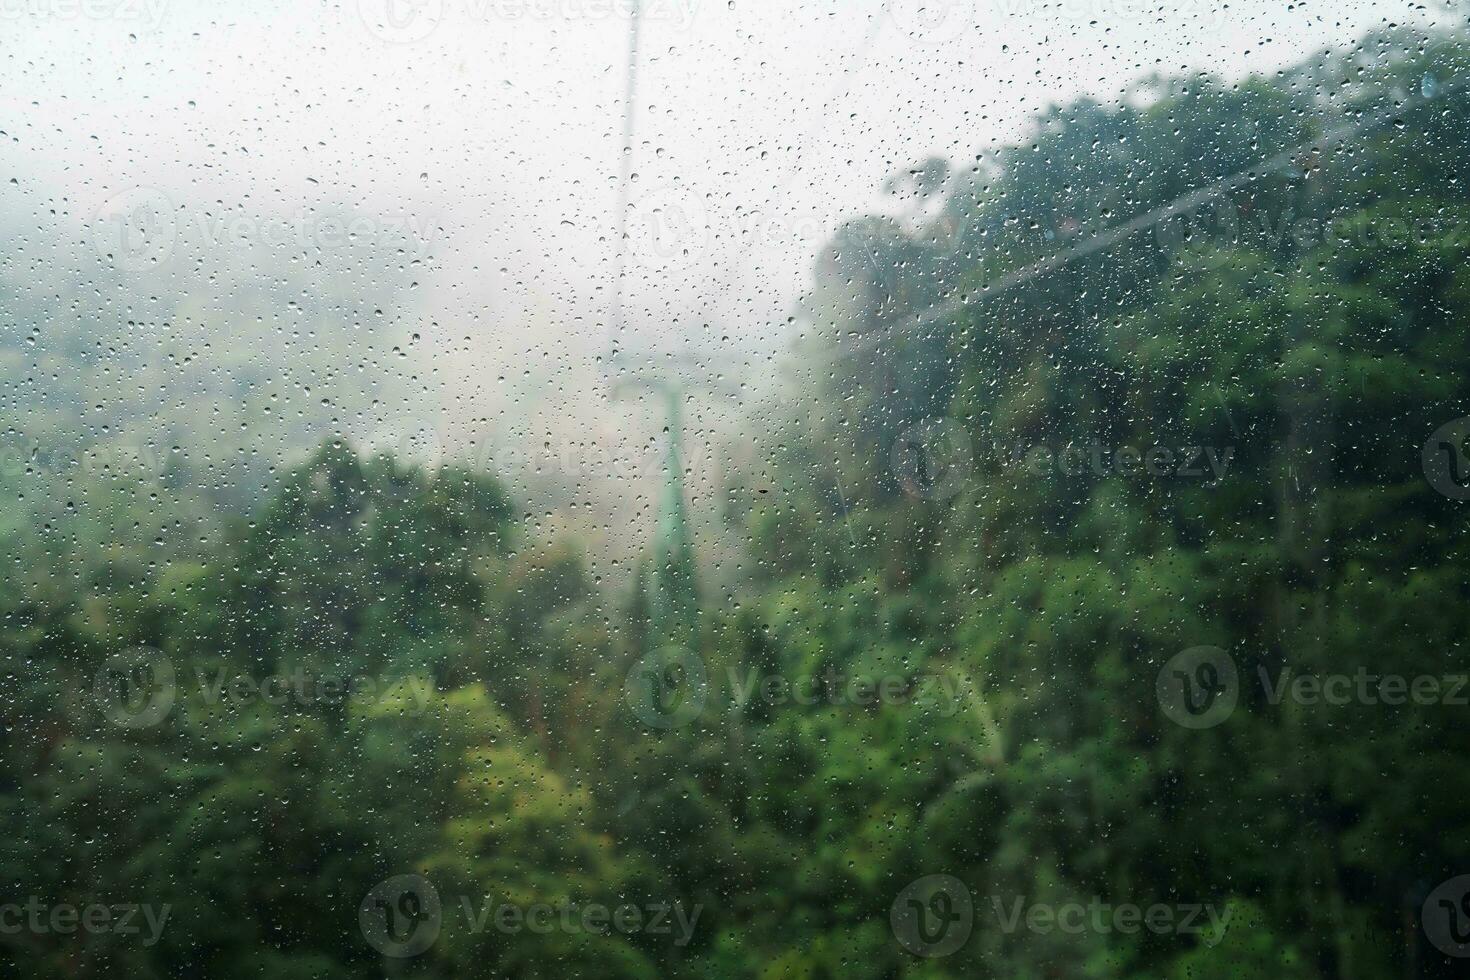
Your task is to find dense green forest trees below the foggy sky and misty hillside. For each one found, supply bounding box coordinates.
[0,22,1470,980]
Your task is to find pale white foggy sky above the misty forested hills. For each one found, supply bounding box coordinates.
[0,0,1434,348]
